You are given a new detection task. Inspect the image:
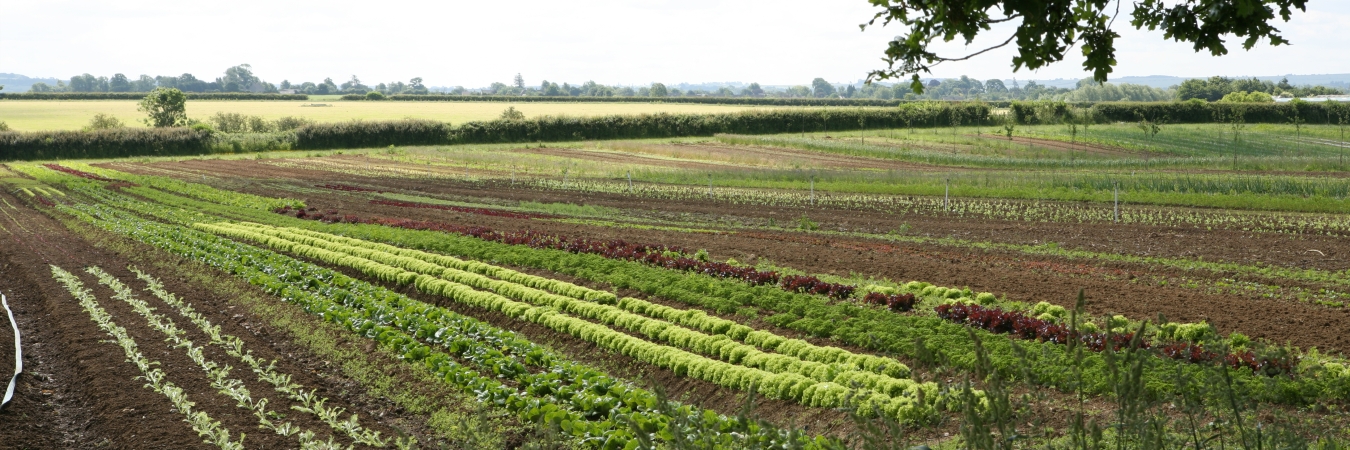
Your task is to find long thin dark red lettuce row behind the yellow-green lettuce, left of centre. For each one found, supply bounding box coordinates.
[275,205,858,297]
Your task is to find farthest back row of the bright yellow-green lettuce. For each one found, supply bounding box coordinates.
[224,218,909,381]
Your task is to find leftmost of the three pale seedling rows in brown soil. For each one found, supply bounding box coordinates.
[51,265,244,450]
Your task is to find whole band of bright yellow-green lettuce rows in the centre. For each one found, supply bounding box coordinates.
[193,223,946,423]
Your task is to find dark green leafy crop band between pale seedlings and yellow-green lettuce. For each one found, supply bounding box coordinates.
[62,200,836,449]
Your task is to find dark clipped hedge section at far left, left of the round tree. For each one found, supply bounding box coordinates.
[0,128,212,161]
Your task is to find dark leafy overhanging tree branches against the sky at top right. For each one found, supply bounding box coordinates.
[861,0,1307,92]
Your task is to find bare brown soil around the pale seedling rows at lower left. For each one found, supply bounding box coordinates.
[0,190,432,449]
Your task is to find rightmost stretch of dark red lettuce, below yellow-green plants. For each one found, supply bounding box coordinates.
[934,304,1295,377]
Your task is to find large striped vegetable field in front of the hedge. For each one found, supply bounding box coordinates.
[0,120,1350,449]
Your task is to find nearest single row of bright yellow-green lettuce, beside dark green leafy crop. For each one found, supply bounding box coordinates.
[193,223,941,422]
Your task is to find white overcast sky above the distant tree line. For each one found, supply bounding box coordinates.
[0,0,1350,88]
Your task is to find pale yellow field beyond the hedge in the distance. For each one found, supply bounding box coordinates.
[0,99,788,131]
